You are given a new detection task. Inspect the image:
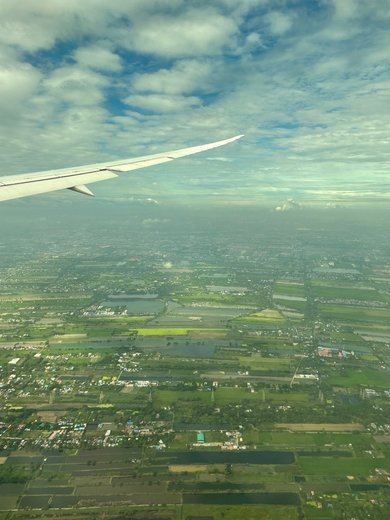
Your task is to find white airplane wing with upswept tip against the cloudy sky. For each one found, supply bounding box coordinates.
[0,135,243,201]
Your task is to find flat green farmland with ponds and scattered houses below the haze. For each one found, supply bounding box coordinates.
[0,208,390,520]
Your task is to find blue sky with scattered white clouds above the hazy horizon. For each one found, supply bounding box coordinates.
[0,0,390,209]
